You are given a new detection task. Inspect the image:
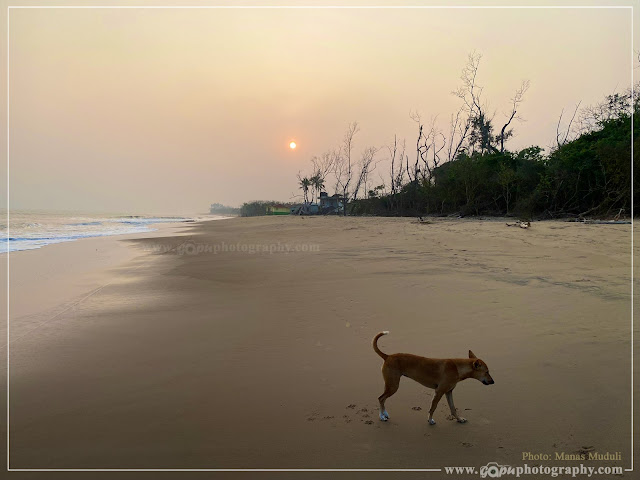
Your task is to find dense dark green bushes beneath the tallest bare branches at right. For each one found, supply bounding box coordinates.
[349,85,640,218]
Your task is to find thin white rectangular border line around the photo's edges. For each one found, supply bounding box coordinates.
[7,5,635,472]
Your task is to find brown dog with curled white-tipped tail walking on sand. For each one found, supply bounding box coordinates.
[373,332,494,425]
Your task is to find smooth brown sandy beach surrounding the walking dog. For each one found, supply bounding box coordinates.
[3,217,638,478]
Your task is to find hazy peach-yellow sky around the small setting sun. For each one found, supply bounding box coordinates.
[0,2,637,213]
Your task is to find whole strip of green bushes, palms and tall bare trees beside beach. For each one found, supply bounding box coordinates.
[292,53,640,218]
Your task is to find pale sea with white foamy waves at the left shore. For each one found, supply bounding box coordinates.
[0,211,211,254]
